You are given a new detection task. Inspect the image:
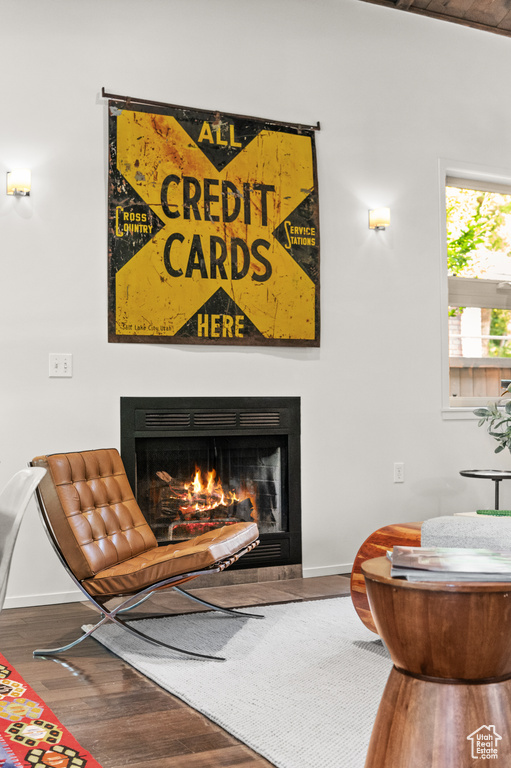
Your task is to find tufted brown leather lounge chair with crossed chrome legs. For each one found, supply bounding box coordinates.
[31,449,262,659]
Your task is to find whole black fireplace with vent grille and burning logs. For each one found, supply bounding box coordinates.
[121,397,302,568]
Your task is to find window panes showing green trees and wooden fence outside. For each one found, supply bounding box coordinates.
[446,176,511,407]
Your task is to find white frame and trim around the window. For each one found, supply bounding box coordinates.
[439,160,511,419]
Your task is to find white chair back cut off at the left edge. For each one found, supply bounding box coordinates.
[0,467,46,610]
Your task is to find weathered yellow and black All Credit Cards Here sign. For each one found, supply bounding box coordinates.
[109,101,319,346]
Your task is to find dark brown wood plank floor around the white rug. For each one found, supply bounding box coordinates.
[0,576,349,768]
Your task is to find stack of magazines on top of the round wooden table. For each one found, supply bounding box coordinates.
[387,546,511,582]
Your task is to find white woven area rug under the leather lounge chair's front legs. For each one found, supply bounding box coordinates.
[88,597,392,768]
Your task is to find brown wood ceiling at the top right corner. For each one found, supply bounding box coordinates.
[360,0,511,37]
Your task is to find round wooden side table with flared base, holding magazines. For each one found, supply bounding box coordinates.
[362,557,511,768]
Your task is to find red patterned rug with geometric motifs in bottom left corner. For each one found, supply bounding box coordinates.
[0,654,101,768]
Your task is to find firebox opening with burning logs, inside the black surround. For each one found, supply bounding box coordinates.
[136,435,288,542]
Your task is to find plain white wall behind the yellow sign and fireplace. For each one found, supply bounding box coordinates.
[0,0,511,605]
